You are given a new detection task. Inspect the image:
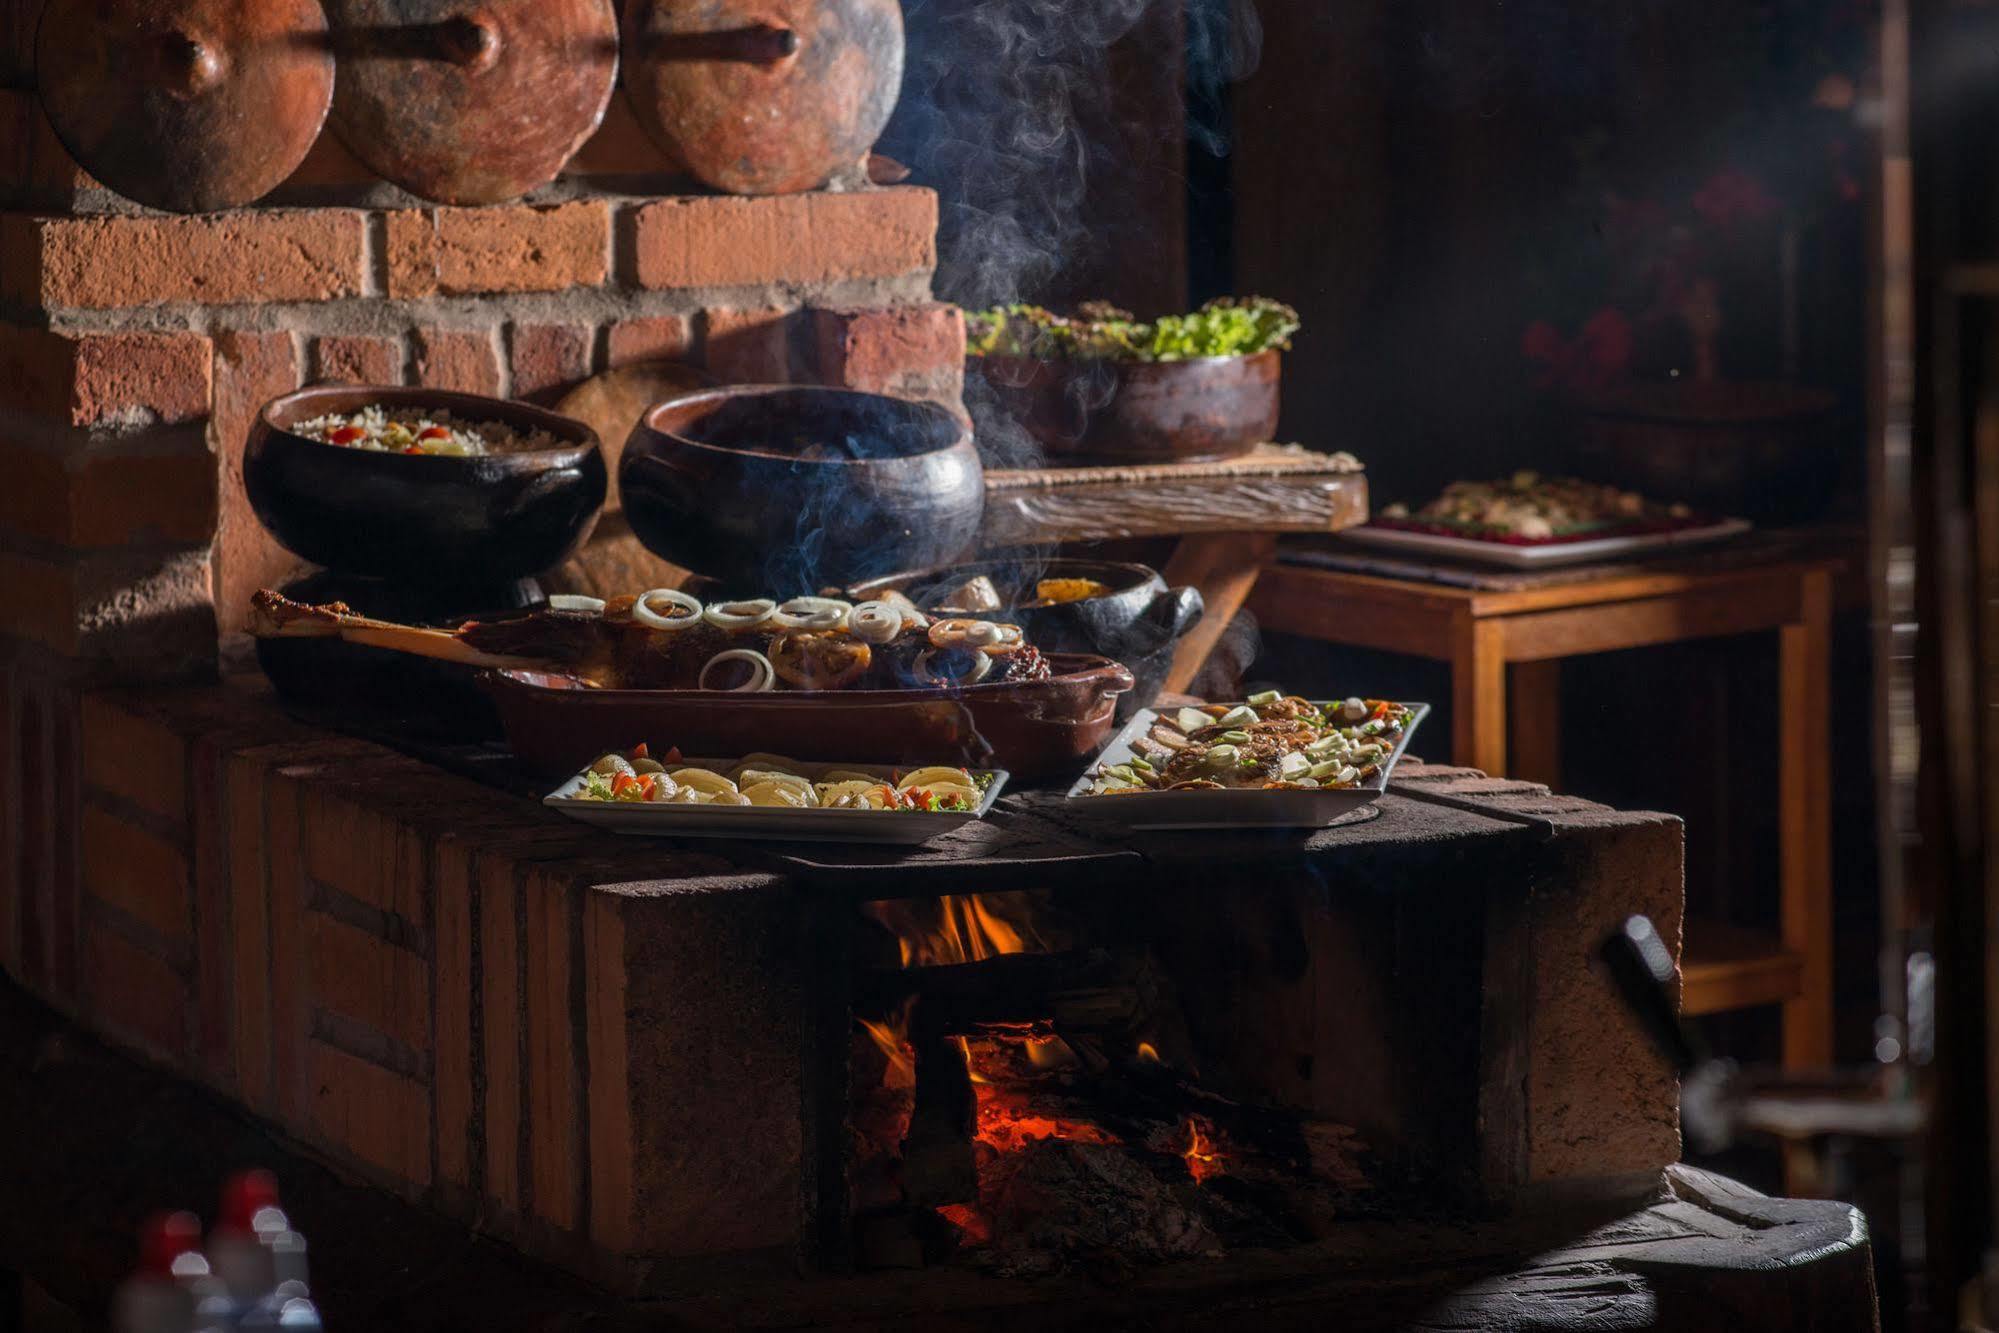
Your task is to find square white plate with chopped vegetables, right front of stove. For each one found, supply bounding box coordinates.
[1069,689,1429,829]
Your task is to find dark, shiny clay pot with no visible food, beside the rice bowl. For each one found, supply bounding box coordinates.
[618,386,986,596]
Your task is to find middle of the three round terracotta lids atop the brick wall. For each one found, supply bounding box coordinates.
[326,0,618,204]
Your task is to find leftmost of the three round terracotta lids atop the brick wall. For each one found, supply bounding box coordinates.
[34,0,334,214]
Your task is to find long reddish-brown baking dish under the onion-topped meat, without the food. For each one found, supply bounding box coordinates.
[480,654,1131,779]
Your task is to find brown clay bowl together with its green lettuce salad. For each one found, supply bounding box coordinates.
[966,298,1297,466]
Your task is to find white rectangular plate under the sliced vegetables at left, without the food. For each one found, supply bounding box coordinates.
[542,759,1007,847]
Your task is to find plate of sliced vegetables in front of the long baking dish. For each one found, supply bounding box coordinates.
[542,743,1007,845]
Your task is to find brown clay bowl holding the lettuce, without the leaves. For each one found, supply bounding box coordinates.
[970,350,1279,464]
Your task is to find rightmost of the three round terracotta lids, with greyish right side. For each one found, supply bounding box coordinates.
[624,0,902,194]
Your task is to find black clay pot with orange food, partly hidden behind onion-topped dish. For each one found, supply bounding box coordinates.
[848,558,1203,717]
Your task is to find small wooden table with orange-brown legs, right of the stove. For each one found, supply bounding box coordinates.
[1249,554,1839,1069]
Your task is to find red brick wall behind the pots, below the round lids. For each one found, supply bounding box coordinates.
[0,41,964,677]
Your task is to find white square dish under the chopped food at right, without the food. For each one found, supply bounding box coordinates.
[1069,699,1429,829]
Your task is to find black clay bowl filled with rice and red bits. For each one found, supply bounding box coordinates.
[244,384,608,586]
